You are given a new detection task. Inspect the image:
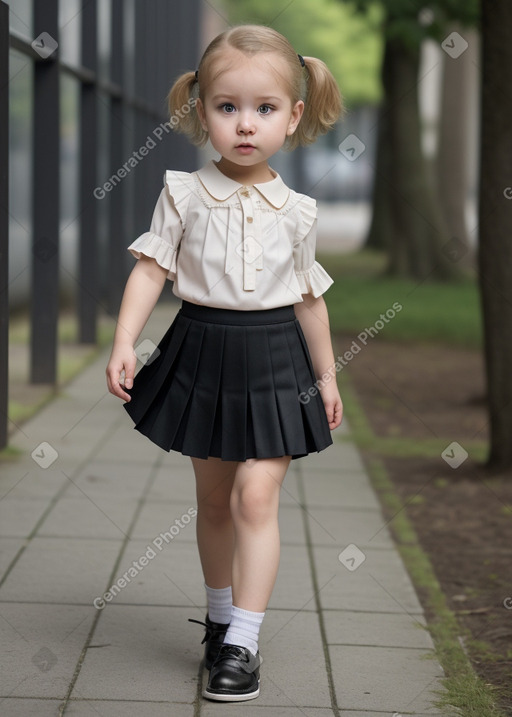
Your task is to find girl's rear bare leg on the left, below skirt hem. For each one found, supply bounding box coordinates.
[191,458,238,588]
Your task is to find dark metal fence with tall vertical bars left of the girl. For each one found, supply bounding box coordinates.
[0,0,199,447]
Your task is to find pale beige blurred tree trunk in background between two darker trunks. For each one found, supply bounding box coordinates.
[437,24,474,254]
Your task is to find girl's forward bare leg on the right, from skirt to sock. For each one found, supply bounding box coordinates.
[226,456,291,612]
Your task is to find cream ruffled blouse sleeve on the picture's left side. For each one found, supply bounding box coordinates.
[128,171,193,281]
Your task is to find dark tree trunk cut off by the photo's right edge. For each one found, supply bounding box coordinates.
[478,0,512,469]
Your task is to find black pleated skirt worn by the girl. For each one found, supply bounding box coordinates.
[124,301,332,461]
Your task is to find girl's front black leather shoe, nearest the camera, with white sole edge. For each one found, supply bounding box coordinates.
[203,644,260,702]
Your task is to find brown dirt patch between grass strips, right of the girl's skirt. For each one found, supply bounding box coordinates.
[341,339,488,444]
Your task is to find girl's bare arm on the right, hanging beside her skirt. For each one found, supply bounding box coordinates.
[295,294,343,431]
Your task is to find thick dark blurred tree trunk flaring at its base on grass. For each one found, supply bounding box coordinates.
[383,38,459,280]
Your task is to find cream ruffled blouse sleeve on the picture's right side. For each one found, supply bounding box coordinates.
[293,196,334,299]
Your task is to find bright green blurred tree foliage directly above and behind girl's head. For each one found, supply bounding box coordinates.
[223,0,382,107]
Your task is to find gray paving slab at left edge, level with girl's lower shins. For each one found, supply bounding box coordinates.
[0,538,121,604]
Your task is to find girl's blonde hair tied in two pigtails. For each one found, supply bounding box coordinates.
[168,25,344,149]
